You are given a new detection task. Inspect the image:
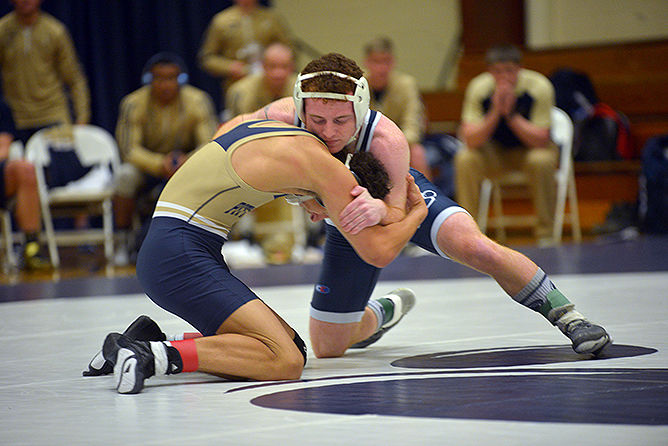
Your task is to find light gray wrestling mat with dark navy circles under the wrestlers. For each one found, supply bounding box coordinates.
[0,270,668,446]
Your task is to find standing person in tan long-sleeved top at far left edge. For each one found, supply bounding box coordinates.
[0,0,90,144]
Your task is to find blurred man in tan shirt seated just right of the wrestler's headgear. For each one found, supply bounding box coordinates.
[364,37,432,179]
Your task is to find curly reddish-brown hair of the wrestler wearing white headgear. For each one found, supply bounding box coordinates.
[300,53,364,94]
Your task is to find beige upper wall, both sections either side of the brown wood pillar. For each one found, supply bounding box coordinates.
[272,0,668,90]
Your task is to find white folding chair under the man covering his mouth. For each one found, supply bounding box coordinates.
[478,107,582,244]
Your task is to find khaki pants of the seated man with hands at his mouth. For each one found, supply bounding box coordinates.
[455,143,559,237]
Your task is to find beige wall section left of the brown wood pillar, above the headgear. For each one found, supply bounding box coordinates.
[272,0,460,88]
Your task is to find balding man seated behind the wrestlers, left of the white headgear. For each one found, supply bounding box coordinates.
[225,42,296,264]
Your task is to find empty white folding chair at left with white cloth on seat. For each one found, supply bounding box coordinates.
[26,125,120,268]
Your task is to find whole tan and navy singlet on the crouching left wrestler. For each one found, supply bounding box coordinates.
[137,120,324,335]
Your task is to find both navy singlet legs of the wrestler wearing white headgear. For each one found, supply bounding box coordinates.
[311,169,466,324]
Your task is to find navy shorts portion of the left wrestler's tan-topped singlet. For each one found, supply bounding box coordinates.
[137,217,258,336]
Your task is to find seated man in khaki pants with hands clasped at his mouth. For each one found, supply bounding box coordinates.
[455,45,559,241]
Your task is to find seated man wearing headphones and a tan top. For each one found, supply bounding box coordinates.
[114,52,217,264]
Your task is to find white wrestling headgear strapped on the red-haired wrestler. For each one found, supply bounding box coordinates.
[292,71,371,134]
